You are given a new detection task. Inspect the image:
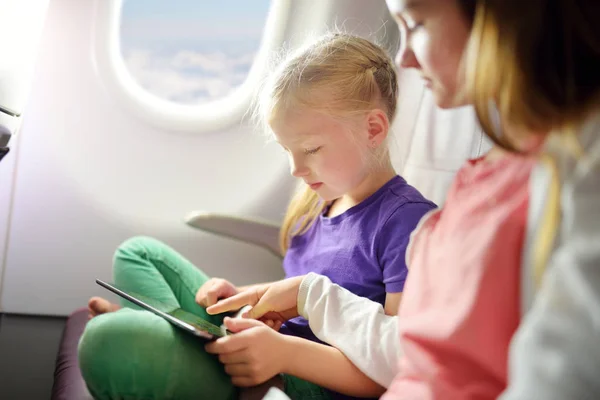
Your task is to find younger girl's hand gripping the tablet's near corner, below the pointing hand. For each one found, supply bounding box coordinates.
[206,318,291,387]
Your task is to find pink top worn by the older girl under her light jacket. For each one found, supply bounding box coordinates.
[382,154,535,400]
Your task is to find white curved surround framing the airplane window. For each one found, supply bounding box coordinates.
[92,0,291,134]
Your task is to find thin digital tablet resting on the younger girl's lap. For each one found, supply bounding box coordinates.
[96,279,230,340]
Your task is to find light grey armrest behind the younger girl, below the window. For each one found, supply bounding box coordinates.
[185,211,281,258]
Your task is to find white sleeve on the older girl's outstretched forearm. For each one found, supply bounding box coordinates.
[298,273,401,387]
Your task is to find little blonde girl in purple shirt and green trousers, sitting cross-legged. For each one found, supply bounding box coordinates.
[79,34,435,399]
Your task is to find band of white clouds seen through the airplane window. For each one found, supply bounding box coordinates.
[124,49,255,104]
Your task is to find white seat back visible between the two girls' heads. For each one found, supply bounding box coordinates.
[390,70,491,206]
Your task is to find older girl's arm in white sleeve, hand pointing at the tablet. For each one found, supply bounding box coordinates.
[207,273,401,387]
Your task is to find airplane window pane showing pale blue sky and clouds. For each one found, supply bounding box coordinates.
[120,0,270,105]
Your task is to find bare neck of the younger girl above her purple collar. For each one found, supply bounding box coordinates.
[327,163,397,217]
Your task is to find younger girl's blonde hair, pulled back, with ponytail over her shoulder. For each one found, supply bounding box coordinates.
[255,33,398,254]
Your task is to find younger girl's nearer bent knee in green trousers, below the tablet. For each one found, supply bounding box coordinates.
[79,309,235,399]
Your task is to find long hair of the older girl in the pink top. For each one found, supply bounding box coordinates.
[461,0,600,151]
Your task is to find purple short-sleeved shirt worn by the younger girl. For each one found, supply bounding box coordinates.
[280,176,436,342]
